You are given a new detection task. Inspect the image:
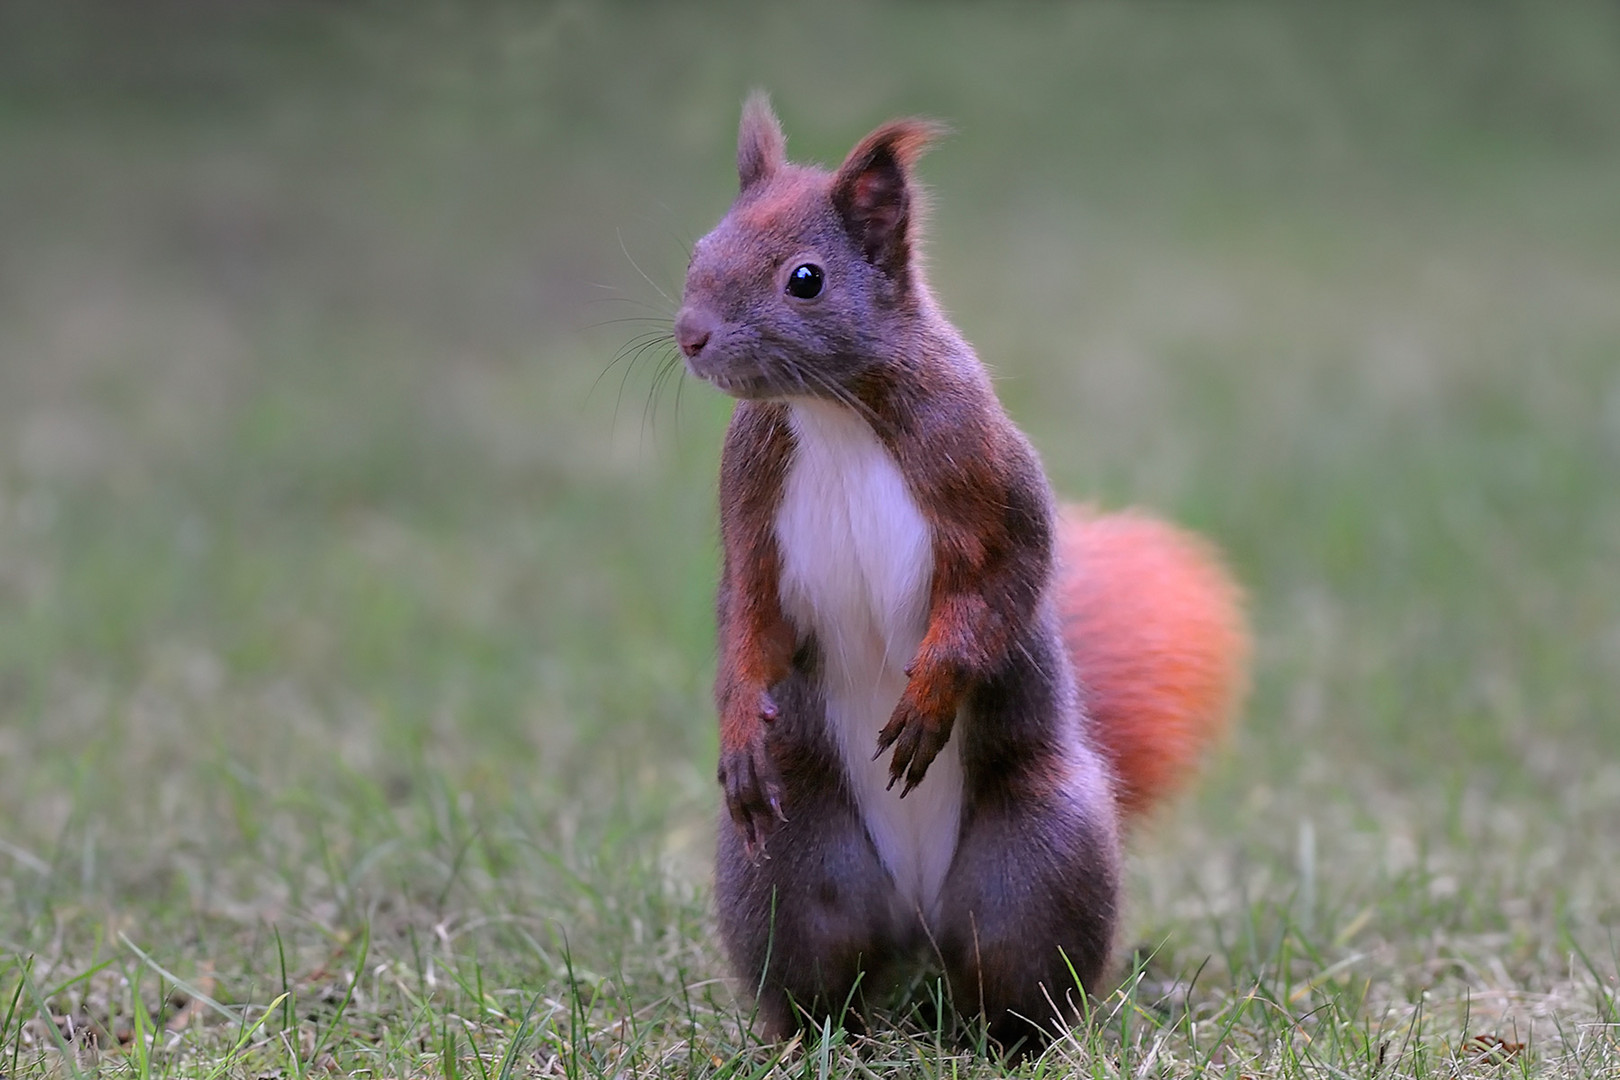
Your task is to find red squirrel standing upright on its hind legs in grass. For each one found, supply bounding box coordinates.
[674,96,1247,1046]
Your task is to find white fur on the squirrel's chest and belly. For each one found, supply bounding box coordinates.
[776,402,962,916]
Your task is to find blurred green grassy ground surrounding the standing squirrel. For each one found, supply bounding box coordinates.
[0,3,1620,1078]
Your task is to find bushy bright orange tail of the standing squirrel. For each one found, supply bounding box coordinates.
[1058,507,1249,821]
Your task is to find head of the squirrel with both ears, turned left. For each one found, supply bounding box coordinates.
[676,94,941,398]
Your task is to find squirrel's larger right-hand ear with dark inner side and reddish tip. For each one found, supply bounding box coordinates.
[833,120,944,279]
